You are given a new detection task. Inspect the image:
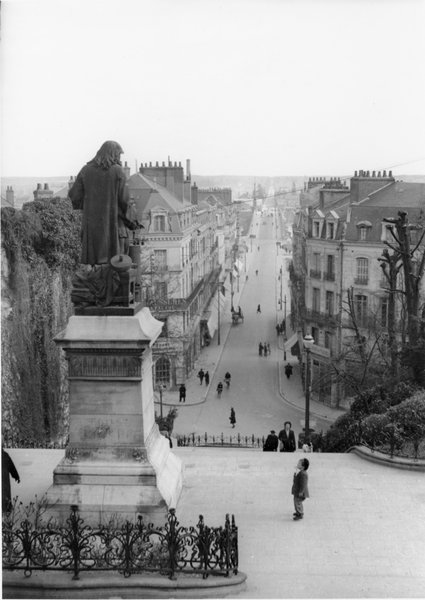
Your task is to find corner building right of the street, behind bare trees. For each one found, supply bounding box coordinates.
[290,171,425,406]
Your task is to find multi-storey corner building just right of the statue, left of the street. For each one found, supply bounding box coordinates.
[127,161,232,388]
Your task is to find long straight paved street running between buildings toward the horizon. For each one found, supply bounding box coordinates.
[164,216,340,437]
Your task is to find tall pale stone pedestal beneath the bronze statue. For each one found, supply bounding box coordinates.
[47,308,182,524]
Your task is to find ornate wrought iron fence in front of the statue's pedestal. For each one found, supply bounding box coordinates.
[2,506,238,579]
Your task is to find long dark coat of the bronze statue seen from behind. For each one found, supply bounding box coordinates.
[69,162,128,265]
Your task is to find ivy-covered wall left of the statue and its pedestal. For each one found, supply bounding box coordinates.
[1,198,81,446]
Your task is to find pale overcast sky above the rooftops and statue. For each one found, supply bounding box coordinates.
[1,0,425,176]
